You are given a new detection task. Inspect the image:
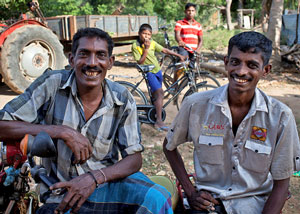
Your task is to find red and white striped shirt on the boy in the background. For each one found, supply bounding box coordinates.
[175,18,203,50]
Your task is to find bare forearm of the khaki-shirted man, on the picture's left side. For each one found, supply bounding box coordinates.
[163,139,196,197]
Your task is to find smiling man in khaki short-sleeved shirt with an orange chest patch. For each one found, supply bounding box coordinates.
[164,31,300,214]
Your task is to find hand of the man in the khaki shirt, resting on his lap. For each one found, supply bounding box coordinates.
[188,191,219,211]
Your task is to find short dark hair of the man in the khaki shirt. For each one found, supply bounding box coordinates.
[227,31,272,65]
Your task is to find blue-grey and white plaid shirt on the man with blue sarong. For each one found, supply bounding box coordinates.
[0,70,143,181]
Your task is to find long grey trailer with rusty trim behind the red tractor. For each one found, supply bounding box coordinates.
[46,15,158,54]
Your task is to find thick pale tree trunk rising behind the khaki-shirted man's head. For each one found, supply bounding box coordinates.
[267,0,284,61]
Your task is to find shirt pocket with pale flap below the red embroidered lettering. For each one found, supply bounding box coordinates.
[196,135,224,164]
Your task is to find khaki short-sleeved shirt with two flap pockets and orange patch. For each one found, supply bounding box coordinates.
[166,85,300,214]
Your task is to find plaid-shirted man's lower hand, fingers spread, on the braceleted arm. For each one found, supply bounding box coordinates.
[50,174,96,214]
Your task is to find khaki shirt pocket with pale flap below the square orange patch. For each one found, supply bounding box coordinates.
[242,140,272,172]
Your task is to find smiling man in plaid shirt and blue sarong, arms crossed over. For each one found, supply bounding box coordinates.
[0,28,173,214]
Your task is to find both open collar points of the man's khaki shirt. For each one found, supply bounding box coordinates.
[210,84,268,112]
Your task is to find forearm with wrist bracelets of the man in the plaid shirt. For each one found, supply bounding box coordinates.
[92,152,142,184]
